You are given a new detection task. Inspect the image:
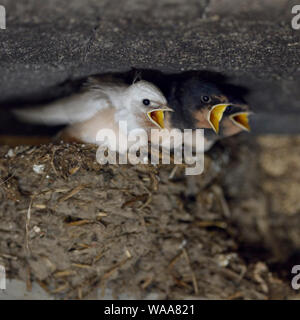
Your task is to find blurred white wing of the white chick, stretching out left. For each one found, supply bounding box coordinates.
[13,91,110,125]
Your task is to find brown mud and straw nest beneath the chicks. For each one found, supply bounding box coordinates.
[0,136,300,299]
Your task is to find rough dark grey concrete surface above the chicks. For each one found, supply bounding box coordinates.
[0,0,300,133]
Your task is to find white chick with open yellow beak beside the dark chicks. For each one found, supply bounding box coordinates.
[14,76,173,151]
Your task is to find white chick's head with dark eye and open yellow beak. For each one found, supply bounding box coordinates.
[127,80,173,129]
